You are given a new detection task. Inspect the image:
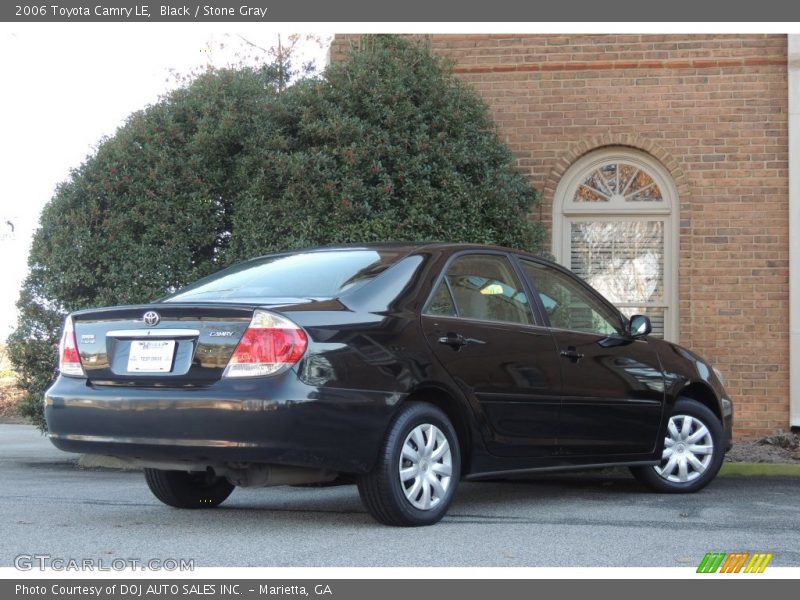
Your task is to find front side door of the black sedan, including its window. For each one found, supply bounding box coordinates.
[520,259,664,456]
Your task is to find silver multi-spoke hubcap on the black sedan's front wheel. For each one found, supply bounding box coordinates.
[653,415,714,483]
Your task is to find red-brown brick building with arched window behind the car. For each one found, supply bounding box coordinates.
[331,34,800,438]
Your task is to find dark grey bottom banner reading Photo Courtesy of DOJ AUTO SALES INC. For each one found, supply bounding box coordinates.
[0,575,797,600]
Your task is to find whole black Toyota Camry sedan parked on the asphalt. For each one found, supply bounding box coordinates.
[45,243,733,525]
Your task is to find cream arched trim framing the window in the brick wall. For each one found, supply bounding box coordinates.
[552,146,680,342]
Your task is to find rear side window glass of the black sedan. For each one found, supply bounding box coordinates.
[428,254,533,325]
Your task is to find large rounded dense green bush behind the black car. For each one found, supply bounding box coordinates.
[9,36,542,427]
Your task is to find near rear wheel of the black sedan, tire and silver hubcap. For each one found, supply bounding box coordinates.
[357,402,461,527]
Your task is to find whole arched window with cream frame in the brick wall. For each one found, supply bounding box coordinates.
[553,147,678,341]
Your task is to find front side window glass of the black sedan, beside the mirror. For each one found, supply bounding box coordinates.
[522,260,622,335]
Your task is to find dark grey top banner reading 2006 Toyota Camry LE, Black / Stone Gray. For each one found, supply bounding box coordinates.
[0,0,800,23]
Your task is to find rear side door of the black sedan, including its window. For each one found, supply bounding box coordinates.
[422,253,561,457]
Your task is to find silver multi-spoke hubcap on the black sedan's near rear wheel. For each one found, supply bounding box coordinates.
[399,423,453,510]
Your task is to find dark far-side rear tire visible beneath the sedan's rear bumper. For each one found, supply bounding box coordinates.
[144,469,234,508]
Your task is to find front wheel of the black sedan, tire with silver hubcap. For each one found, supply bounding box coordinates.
[631,398,726,494]
